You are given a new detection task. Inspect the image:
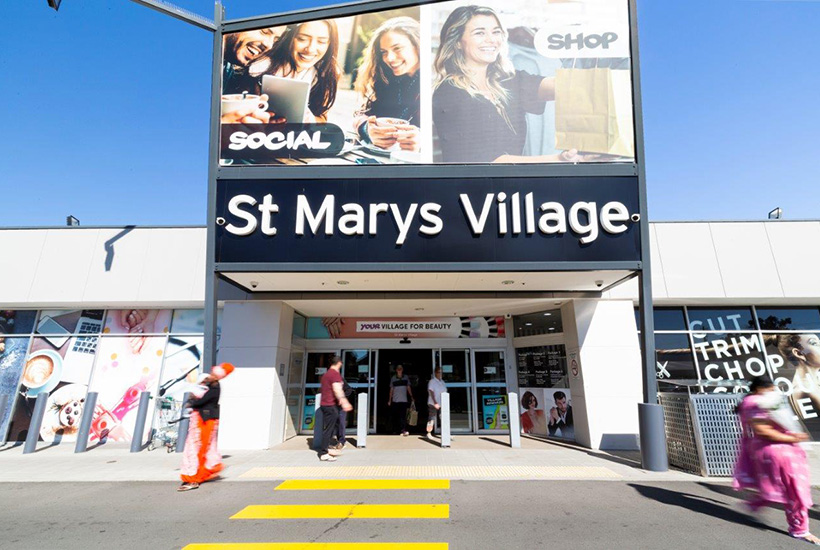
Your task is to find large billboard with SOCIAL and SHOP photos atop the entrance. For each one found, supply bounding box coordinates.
[220,0,635,166]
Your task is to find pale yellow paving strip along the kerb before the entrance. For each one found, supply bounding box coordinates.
[239,465,623,480]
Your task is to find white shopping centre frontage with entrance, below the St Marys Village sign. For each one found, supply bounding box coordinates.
[0,221,820,449]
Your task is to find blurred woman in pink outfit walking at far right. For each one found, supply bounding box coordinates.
[733,377,820,545]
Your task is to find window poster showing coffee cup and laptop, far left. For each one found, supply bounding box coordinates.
[9,309,103,443]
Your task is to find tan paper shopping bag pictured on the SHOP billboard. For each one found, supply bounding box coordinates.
[555,68,635,158]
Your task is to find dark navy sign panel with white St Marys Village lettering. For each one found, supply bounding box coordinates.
[216,177,645,269]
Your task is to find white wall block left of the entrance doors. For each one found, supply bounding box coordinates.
[218,301,293,449]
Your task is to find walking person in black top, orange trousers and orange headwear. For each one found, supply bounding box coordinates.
[177,363,234,491]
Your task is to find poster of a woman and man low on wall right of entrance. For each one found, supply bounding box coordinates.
[520,388,575,440]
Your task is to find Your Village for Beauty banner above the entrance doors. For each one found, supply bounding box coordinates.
[307,317,506,339]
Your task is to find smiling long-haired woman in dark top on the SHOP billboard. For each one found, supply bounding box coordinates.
[433,5,588,163]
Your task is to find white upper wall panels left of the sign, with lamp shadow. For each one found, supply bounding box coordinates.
[0,227,205,308]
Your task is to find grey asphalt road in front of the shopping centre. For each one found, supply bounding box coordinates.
[0,481,820,550]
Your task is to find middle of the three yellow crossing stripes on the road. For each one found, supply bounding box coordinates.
[231,504,450,519]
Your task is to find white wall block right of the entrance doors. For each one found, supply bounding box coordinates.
[561,300,642,450]
